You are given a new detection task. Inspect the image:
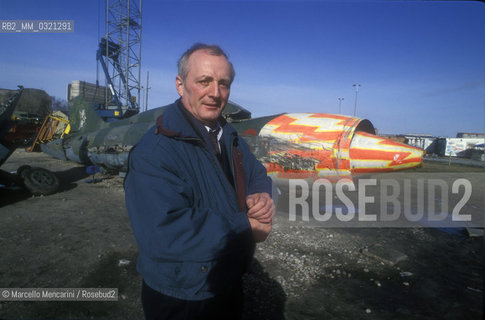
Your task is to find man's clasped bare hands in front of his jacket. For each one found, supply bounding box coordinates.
[246,193,275,242]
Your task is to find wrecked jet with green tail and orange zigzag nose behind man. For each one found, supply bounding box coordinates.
[41,98,424,180]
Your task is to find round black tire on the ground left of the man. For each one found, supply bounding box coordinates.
[23,168,59,196]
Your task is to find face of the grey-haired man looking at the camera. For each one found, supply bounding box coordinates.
[175,50,231,126]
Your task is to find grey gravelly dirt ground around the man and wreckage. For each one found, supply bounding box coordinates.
[0,150,484,319]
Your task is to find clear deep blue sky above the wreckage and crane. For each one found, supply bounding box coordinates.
[0,0,485,137]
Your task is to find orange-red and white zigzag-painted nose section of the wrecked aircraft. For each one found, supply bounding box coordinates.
[253,113,423,180]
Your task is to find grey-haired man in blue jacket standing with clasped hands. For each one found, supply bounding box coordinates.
[125,44,274,319]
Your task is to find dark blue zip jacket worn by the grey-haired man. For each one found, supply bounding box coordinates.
[125,102,271,300]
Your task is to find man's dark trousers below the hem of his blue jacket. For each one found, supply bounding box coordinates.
[141,281,244,320]
